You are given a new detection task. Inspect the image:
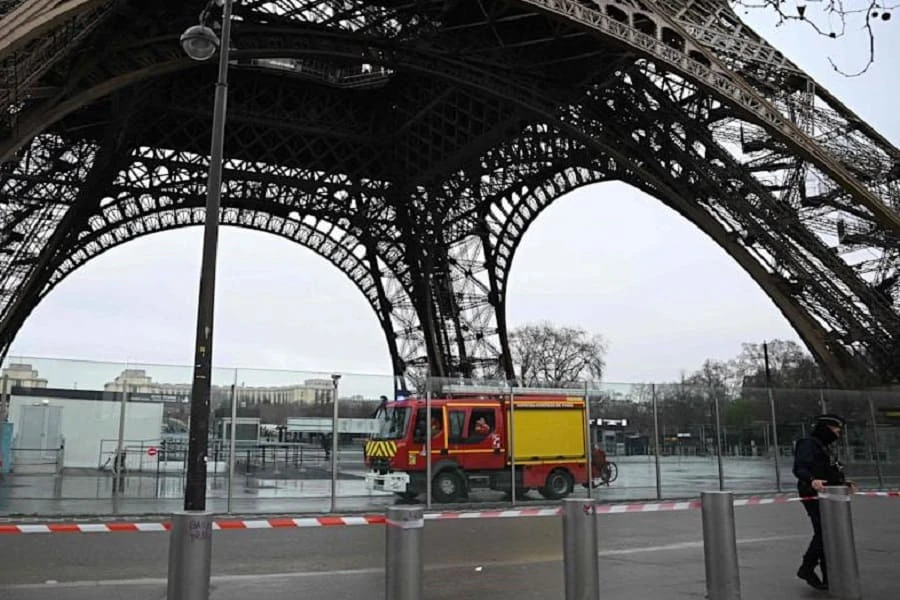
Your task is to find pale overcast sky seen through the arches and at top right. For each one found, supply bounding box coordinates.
[5,12,900,392]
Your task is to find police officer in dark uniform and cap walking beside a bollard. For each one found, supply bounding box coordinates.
[794,414,855,590]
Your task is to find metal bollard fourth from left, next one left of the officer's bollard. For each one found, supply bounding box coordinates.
[700,492,741,600]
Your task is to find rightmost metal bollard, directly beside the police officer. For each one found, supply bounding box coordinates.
[819,486,862,600]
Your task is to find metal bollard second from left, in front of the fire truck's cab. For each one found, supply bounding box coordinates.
[384,506,425,600]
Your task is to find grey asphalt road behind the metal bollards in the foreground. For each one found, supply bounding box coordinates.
[0,498,900,600]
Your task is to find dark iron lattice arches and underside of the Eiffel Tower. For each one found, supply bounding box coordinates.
[0,0,900,386]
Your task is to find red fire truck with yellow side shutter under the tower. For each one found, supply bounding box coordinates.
[364,385,597,502]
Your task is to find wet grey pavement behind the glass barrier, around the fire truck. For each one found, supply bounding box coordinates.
[0,450,900,517]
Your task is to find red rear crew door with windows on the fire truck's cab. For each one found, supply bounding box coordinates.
[447,406,506,470]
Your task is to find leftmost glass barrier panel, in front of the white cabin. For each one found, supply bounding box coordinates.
[0,356,132,514]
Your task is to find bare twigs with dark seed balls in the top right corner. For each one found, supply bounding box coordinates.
[734,0,900,77]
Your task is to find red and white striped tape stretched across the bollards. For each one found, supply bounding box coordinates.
[0,492,900,535]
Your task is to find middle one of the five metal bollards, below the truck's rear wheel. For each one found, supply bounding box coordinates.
[562,498,600,600]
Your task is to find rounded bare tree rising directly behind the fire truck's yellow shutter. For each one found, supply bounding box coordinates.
[509,322,606,385]
